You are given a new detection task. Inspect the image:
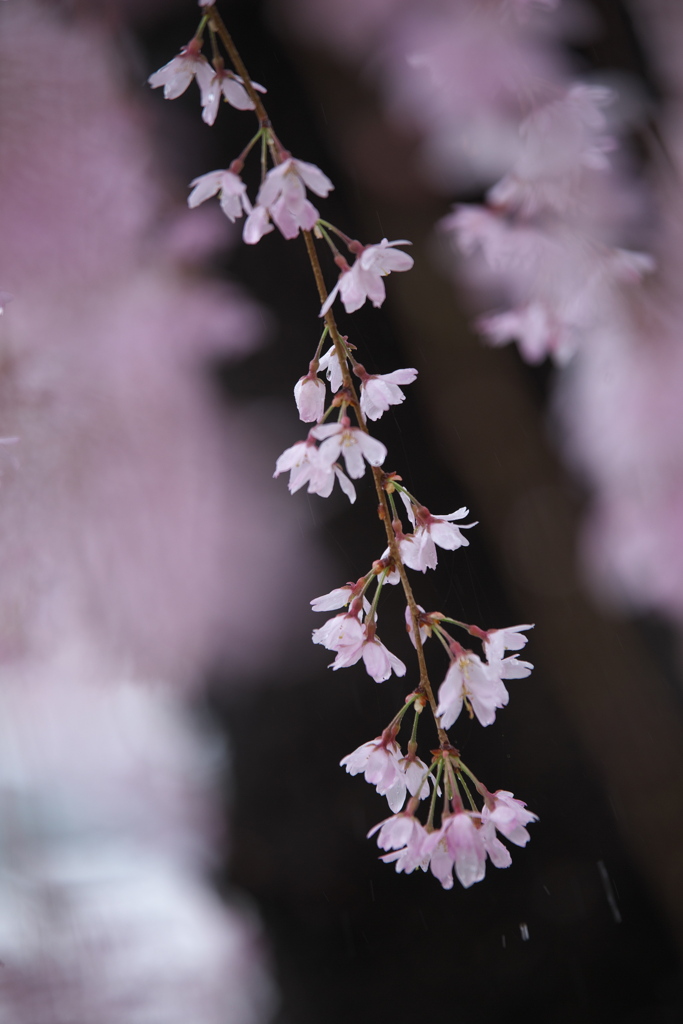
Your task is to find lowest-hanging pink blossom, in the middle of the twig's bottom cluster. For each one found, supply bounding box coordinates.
[423,811,486,889]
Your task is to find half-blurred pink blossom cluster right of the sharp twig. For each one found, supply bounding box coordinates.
[442,84,654,364]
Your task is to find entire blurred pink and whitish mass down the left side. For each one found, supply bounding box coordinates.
[0,0,331,1024]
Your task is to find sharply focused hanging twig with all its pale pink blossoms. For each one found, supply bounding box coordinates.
[150,0,536,888]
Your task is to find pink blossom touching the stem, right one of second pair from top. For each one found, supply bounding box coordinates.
[243,157,334,245]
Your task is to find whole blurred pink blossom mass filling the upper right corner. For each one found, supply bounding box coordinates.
[272,0,683,624]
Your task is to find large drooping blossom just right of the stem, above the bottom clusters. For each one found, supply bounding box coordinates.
[436,651,509,729]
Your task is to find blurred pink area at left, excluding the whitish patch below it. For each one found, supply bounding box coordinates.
[0,3,315,685]
